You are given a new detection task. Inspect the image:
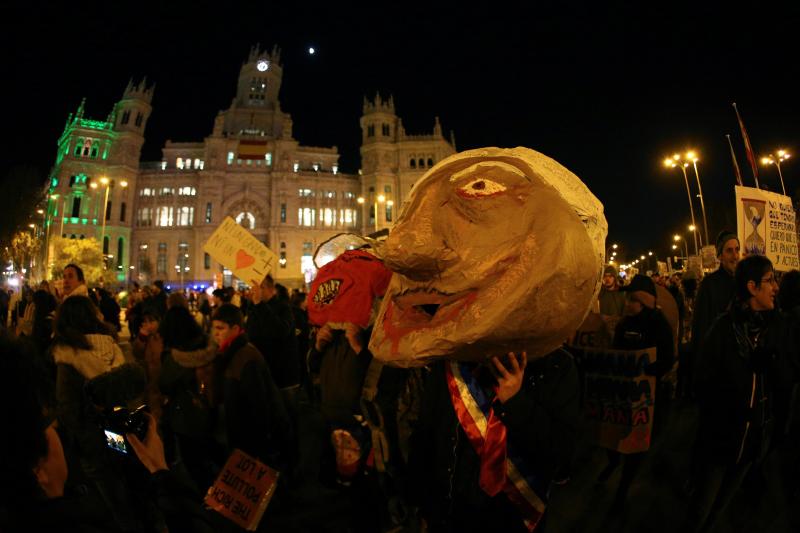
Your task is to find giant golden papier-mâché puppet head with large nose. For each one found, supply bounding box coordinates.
[370,148,606,366]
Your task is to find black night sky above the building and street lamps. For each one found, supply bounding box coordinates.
[0,0,800,262]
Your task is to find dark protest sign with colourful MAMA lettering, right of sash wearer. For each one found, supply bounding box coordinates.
[571,348,656,454]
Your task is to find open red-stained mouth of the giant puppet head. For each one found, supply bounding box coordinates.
[392,289,475,327]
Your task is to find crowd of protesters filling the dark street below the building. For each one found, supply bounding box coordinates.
[0,228,800,531]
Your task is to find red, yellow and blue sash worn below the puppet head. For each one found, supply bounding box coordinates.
[445,361,547,531]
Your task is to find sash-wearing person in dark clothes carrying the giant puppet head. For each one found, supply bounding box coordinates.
[409,350,578,532]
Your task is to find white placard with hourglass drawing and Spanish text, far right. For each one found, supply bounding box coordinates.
[736,185,800,272]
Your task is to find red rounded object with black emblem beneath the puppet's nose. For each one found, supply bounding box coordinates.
[307,250,392,329]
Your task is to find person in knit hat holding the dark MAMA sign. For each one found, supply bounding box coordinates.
[598,274,675,515]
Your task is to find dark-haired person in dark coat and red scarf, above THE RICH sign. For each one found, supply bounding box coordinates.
[211,304,293,471]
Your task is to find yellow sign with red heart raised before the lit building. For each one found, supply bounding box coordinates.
[203,217,278,284]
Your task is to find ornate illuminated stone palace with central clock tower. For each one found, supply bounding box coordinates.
[45,48,454,287]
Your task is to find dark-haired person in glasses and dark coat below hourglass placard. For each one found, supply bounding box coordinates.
[682,255,796,531]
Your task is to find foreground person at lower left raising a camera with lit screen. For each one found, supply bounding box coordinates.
[0,336,226,533]
